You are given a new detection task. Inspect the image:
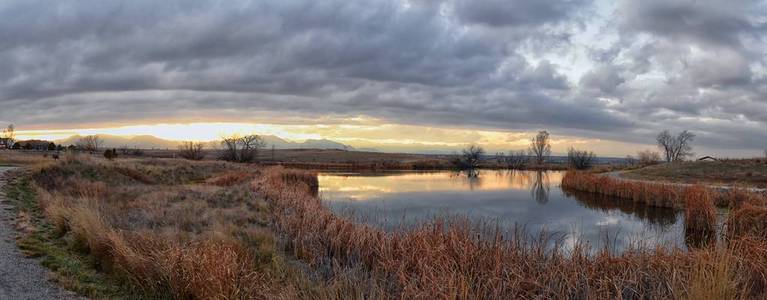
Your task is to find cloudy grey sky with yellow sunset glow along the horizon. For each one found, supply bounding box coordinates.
[0,0,767,157]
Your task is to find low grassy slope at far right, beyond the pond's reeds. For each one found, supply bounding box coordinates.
[621,159,767,188]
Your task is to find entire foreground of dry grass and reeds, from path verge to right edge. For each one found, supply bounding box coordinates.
[4,152,767,299]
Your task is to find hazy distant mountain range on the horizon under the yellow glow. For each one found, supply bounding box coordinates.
[54,134,355,150]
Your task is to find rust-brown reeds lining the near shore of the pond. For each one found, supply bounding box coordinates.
[254,169,765,299]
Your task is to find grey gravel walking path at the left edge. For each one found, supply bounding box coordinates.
[0,167,82,299]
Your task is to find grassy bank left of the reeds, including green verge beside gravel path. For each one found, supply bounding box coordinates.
[2,156,372,299]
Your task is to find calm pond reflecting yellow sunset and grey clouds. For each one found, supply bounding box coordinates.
[319,170,704,251]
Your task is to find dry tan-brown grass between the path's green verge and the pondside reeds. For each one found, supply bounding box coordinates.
[27,156,290,299]
